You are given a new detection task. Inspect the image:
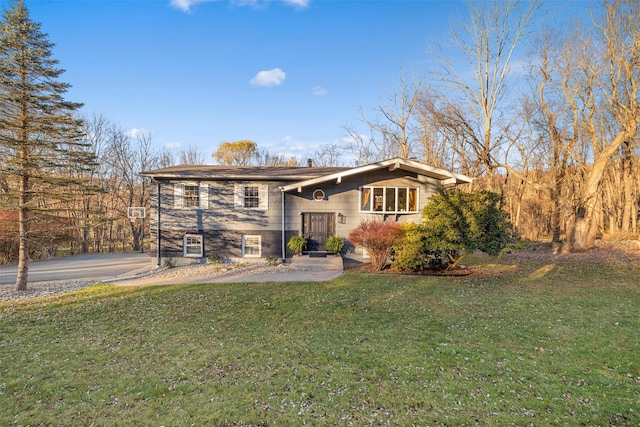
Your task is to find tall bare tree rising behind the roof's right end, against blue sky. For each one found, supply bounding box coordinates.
[430,0,541,175]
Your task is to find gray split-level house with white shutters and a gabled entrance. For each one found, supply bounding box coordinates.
[142,158,471,264]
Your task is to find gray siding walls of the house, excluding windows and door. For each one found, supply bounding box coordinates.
[149,170,439,258]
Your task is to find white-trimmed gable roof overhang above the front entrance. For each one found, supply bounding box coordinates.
[280,158,473,192]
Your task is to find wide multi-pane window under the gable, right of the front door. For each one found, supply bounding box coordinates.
[360,187,418,213]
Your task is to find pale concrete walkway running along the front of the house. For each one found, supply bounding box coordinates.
[108,255,344,286]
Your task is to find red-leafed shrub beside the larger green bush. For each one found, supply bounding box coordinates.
[349,220,403,271]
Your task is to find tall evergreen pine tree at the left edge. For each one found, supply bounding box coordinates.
[0,0,94,291]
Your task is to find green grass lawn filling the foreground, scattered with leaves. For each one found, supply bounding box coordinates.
[0,257,640,426]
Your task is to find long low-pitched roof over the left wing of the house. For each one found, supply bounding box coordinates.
[140,165,351,181]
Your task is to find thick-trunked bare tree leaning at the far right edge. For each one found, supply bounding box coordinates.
[563,0,640,251]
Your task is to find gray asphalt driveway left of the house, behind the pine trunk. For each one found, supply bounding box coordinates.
[0,253,155,285]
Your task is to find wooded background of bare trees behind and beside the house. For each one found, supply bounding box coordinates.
[0,0,640,262]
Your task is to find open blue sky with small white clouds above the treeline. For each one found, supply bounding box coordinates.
[15,0,584,163]
